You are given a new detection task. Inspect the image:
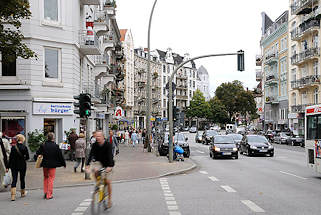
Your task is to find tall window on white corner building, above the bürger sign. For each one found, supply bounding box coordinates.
[45,48,59,79]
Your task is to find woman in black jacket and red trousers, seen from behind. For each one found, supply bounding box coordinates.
[36,132,66,199]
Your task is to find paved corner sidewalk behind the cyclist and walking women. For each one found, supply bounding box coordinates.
[17,145,196,189]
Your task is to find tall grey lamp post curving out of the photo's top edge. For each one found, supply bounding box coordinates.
[145,0,157,152]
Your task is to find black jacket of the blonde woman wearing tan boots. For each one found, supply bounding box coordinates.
[8,143,29,170]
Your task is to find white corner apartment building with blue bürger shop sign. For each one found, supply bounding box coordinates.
[0,0,124,142]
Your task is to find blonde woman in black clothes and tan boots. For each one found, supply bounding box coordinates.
[8,134,29,201]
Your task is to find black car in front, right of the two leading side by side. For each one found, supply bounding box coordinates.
[240,135,274,157]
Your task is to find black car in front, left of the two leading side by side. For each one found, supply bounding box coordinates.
[209,135,239,159]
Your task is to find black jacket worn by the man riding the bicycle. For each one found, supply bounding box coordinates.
[86,141,115,167]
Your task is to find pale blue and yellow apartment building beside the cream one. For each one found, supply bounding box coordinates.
[261,11,289,130]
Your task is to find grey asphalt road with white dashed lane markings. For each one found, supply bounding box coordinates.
[0,133,321,215]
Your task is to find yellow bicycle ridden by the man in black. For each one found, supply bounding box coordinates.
[91,168,109,215]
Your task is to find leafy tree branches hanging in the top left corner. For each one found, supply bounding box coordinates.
[0,0,36,62]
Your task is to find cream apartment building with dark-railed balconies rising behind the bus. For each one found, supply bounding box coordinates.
[289,0,321,135]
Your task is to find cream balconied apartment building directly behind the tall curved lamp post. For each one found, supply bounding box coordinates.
[134,48,162,129]
